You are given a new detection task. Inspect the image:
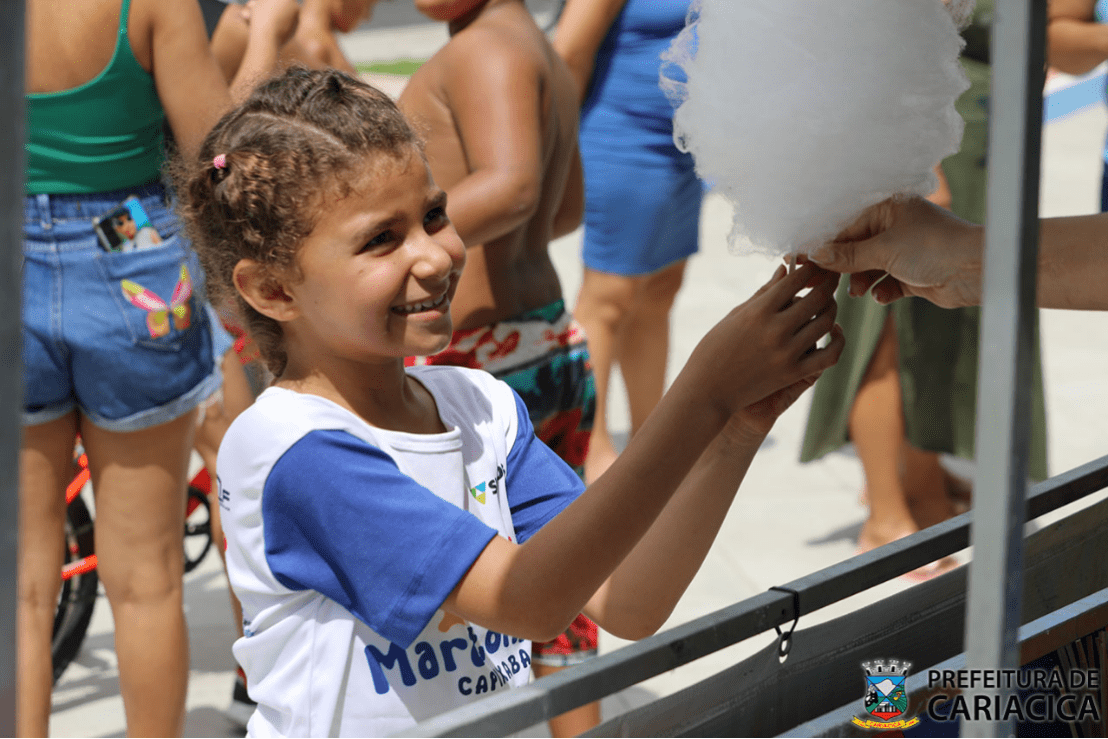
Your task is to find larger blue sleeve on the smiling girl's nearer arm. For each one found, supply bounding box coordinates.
[261,431,496,648]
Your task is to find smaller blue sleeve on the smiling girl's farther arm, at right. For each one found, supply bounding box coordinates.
[505,391,585,544]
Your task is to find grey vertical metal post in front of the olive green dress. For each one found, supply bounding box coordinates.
[962,0,1047,737]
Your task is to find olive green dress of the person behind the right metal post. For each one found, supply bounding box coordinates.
[800,0,1047,480]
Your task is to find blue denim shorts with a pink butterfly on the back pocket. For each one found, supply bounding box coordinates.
[23,183,223,432]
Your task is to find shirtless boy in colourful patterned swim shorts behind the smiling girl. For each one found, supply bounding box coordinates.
[399,0,599,736]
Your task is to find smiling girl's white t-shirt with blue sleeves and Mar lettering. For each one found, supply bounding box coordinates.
[211,367,583,736]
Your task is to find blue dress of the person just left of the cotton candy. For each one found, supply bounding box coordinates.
[581,0,704,276]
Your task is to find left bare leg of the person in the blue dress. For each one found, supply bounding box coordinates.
[573,267,635,483]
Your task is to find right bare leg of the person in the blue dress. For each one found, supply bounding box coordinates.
[617,259,686,435]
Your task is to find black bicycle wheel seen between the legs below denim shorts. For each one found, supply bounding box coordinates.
[51,495,100,682]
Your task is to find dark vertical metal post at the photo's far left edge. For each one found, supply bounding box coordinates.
[0,0,25,737]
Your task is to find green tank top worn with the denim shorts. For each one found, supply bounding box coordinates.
[25,0,165,195]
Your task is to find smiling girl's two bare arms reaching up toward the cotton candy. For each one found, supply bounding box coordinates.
[443,266,842,640]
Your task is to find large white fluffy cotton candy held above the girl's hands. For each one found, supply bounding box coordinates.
[663,0,973,255]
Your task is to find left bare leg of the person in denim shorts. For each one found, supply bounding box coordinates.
[16,413,76,737]
